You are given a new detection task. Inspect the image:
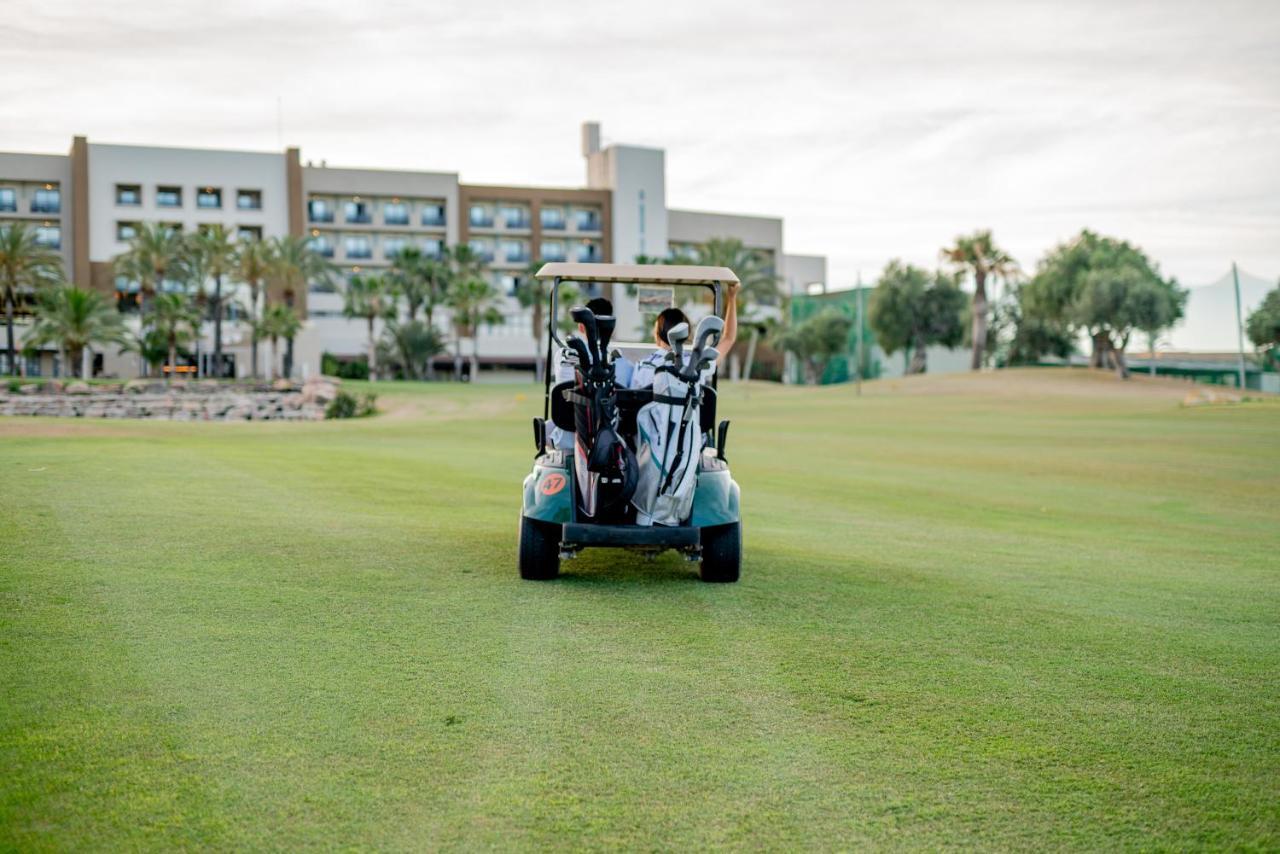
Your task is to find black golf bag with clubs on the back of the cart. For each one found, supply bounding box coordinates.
[564,307,637,522]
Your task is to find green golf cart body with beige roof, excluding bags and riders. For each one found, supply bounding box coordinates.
[520,262,741,581]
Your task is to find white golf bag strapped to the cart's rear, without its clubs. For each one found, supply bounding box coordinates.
[631,370,703,526]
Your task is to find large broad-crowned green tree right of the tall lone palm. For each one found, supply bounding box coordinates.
[1021,230,1187,378]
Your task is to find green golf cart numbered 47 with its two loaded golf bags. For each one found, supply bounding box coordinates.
[520,262,742,583]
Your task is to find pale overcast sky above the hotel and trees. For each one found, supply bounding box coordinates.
[0,0,1280,286]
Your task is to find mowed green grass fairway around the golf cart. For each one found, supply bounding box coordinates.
[0,371,1280,850]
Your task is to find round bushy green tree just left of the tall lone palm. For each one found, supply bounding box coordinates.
[868,260,965,374]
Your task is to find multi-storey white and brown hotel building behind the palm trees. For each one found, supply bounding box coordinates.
[0,123,826,376]
